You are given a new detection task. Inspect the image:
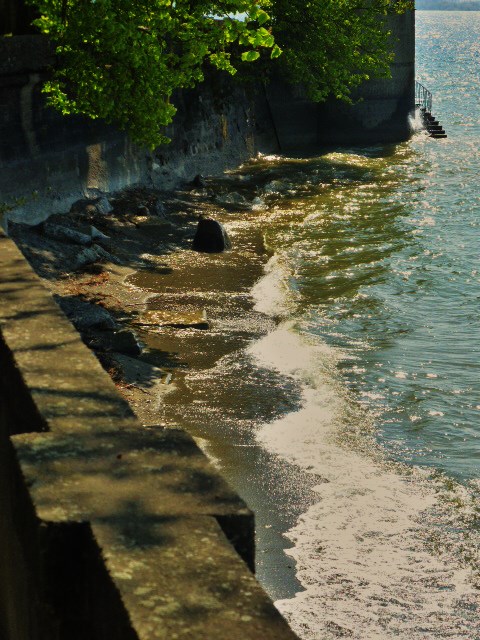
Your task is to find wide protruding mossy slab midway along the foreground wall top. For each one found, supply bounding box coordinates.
[12,427,252,522]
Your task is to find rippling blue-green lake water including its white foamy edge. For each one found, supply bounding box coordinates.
[236,12,480,640]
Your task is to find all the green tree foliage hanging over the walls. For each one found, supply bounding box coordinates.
[28,0,410,148]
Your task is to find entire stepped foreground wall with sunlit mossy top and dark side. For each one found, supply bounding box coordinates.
[0,229,296,640]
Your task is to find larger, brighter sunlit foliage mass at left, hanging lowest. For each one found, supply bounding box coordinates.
[32,0,280,148]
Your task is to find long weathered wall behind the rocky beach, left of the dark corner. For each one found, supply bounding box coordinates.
[0,36,274,224]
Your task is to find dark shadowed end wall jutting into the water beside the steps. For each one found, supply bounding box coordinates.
[267,12,415,153]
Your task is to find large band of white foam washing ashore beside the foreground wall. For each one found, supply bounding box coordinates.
[250,325,480,640]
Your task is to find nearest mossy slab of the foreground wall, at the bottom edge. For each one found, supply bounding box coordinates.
[92,517,296,640]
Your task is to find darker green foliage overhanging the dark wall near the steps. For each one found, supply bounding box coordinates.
[271,0,413,102]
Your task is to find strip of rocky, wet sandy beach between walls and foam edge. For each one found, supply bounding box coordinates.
[9,169,315,599]
